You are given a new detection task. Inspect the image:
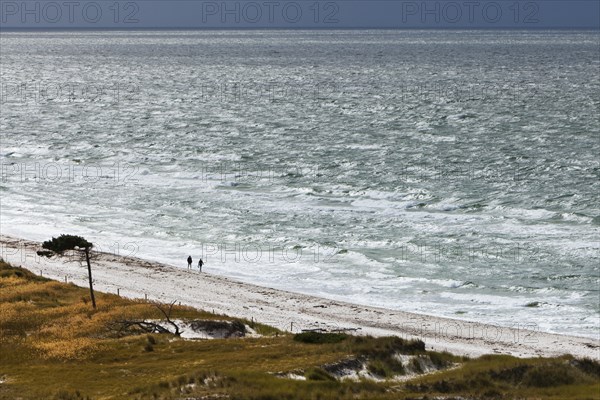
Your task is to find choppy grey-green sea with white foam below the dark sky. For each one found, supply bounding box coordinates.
[0,30,600,338]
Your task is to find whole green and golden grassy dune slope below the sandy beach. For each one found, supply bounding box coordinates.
[0,262,600,400]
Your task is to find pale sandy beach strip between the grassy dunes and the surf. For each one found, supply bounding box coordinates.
[0,235,600,360]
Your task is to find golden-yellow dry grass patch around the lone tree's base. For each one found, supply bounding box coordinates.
[0,264,178,360]
